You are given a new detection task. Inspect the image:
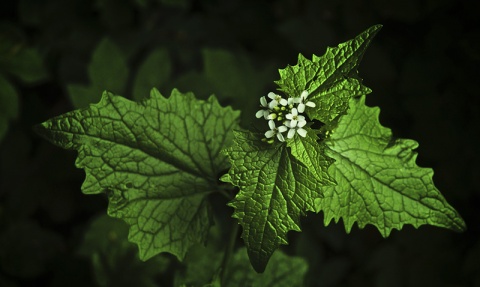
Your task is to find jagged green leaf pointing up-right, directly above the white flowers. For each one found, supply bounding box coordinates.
[275,25,382,124]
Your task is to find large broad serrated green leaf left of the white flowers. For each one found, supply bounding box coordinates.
[36,89,240,260]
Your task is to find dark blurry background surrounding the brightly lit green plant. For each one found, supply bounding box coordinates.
[0,0,480,286]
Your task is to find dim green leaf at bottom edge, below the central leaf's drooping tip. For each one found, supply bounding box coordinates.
[225,248,308,287]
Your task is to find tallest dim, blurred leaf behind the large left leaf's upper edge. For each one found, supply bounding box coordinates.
[67,38,128,108]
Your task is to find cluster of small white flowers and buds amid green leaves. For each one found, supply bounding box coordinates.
[256,91,315,143]
